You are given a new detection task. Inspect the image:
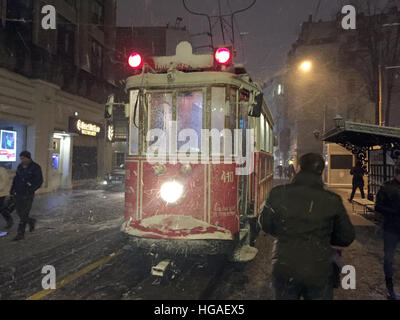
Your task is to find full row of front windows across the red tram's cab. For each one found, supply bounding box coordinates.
[130,86,242,155]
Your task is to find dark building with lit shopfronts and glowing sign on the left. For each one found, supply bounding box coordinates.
[0,0,118,192]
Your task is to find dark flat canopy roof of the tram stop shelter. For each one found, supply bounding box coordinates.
[322,120,400,150]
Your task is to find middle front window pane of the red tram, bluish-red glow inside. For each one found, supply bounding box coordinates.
[177,91,203,152]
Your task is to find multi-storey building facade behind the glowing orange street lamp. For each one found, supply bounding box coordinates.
[265,8,400,187]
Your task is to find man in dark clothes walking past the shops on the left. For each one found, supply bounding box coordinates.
[10,151,43,241]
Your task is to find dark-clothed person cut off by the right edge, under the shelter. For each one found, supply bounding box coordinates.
[375,160,400,300]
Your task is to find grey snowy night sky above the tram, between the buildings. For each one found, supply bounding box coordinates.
[117,0,392,82]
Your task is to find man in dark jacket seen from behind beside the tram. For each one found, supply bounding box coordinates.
[259,153,355,300]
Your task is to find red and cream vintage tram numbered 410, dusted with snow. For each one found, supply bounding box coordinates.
[122,42,274,260]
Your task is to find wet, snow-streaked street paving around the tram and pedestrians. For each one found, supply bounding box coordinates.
[0,182,400,300]
